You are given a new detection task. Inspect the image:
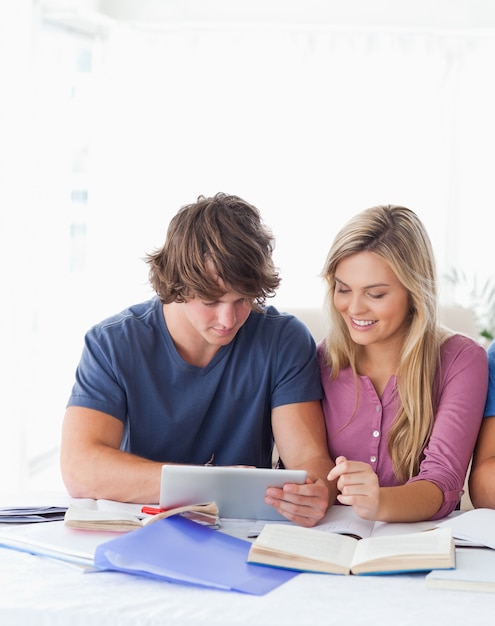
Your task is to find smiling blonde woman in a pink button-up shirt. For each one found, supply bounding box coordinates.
[318,206,488,522]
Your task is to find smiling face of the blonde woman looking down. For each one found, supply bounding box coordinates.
[333,251,410,346]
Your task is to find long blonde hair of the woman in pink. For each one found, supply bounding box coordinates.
[323,205,446,482]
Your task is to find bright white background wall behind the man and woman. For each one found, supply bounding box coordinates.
[0,0,495,488]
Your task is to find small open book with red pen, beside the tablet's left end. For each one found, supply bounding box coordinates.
[64,498,218,532]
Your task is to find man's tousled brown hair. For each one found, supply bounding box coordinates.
[146,193,280,308]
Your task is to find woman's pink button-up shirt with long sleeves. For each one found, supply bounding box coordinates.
[318,335,488,518]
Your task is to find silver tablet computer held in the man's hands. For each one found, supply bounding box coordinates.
[160,465,307,521]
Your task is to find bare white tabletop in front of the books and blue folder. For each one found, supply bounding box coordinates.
[0,536,495,626]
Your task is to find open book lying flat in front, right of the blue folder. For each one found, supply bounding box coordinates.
[248,524,455,574]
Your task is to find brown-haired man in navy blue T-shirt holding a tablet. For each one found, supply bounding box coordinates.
[61,194,335,526]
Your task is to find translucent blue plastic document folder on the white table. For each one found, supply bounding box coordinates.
[94,516,298,595]
